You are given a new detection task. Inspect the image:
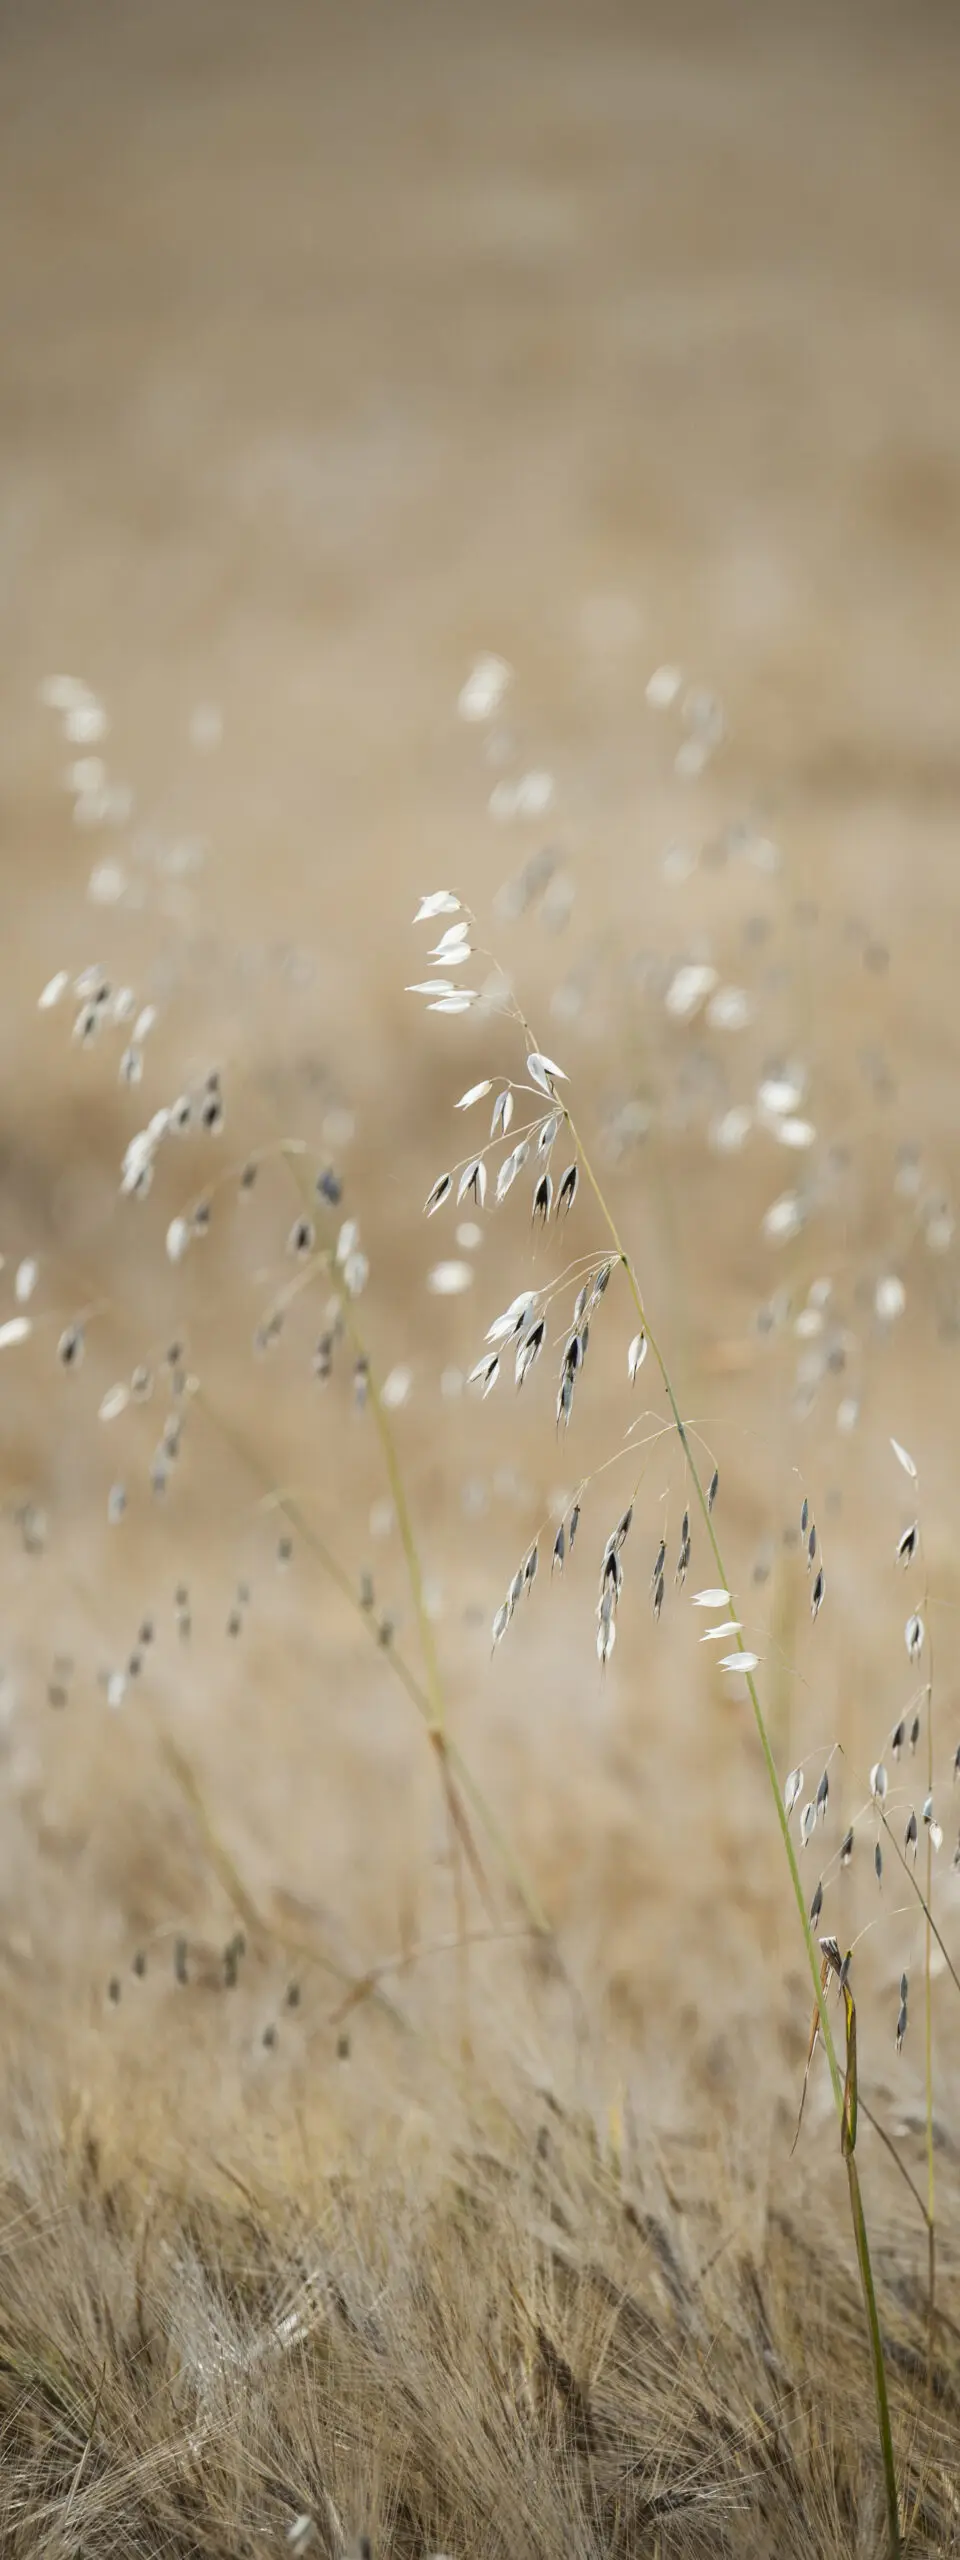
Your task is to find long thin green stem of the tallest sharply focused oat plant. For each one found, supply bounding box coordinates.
[566,1108,901,2560]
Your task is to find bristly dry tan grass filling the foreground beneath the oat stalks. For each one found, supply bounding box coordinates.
[0,2048,960,2560]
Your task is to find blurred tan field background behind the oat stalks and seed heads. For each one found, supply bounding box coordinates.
[0,0,960,2160]
